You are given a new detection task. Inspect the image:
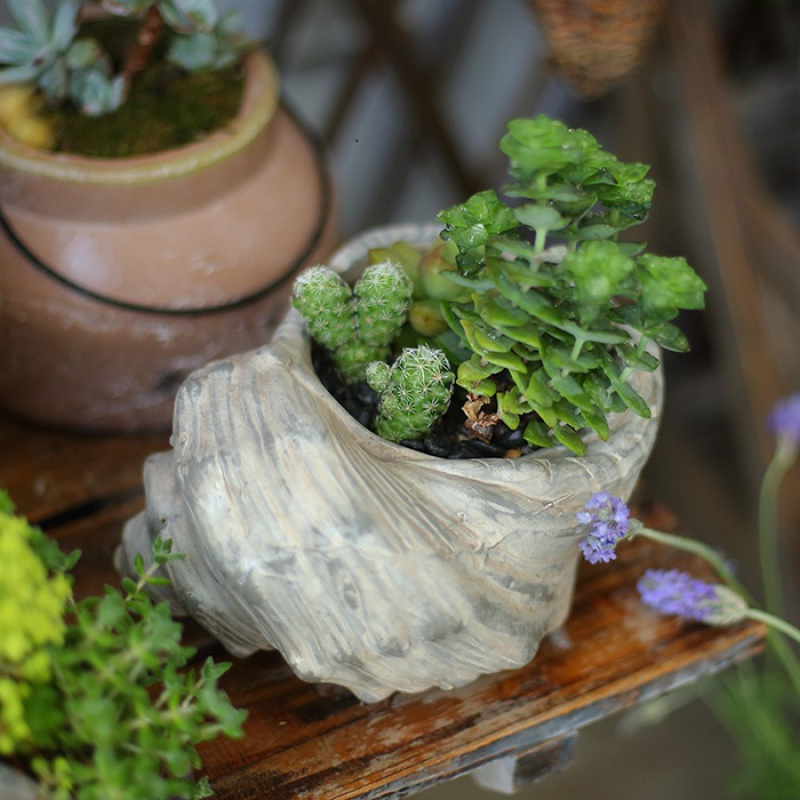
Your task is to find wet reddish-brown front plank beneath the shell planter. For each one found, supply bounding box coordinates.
[197,541,763,800]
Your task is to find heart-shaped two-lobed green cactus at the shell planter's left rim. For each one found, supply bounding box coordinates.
[292,262,412,383]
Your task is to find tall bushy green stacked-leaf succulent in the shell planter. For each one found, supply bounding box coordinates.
[439,116,705,454]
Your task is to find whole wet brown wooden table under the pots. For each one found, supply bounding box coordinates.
[0,417,765,800]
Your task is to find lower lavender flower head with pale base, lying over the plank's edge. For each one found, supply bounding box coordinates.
[637,569,748,625]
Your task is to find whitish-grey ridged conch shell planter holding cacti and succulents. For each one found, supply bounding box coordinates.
[117,223,662,702]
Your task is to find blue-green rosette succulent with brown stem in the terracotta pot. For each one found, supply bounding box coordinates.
[0,0,244,147]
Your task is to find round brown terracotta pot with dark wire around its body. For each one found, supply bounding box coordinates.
[0,53,333,430]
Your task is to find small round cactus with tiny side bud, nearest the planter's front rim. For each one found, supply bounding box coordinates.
[366,345,455,442]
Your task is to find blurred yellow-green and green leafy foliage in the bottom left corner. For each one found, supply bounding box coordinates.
[0,495,244,800]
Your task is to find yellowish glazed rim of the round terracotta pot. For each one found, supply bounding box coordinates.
[0,50,279,186]
